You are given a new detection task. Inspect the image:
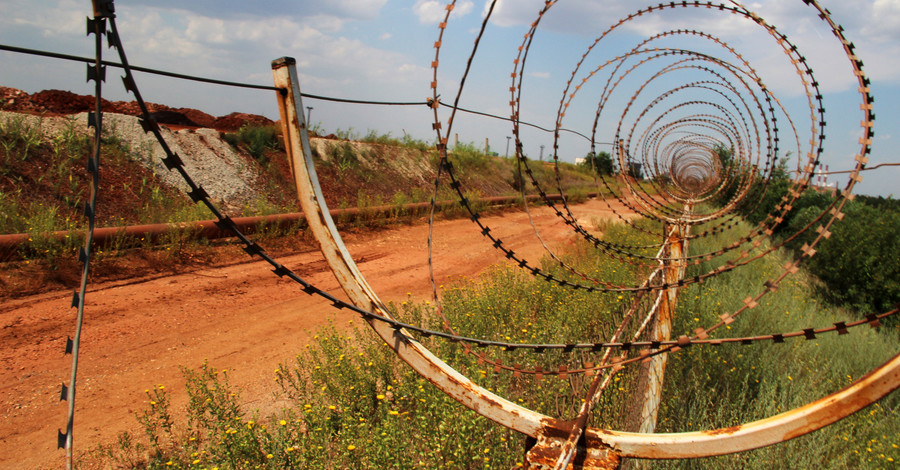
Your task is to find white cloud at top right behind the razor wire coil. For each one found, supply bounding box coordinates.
[482,0,900,95]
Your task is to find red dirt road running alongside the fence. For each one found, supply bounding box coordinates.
[0,197,625,469]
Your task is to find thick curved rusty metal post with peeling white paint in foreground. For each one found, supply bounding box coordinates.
[272,58,900,468]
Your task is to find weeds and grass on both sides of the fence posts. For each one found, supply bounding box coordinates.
[86,212,900,470]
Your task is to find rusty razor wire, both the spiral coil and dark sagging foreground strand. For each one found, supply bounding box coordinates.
[17,0,888,465]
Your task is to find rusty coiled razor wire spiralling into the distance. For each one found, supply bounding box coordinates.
[429,0,893,468]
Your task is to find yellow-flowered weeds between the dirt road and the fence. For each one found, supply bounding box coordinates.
[86,218,660,470]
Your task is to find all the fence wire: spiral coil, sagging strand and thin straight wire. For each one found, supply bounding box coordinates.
[15,0,900,462]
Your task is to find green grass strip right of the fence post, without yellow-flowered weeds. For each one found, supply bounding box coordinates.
[646,219,900,469]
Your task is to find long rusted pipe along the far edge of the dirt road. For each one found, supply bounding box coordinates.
[0,193,597,261]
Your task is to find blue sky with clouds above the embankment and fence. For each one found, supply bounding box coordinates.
[0,0,900,196]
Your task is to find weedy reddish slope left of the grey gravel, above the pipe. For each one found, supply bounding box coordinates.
[0,113,214,262]
